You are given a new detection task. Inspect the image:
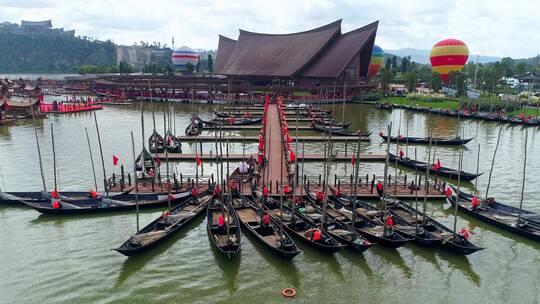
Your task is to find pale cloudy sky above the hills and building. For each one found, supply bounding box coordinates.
[0,0,540,58]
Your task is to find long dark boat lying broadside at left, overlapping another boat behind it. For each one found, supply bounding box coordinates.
[22,192,191,215]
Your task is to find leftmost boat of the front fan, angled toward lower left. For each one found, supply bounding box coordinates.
[113,194,212,256]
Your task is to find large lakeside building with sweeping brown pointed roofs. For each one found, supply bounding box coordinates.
[215,20,378,93]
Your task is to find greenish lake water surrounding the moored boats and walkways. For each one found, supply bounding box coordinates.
[0,104,540,303]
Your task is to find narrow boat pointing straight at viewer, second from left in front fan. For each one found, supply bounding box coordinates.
[206,196,240,258]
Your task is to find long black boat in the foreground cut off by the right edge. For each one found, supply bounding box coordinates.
[447,187,540,241]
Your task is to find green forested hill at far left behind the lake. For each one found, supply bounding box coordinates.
[0,32,116,73]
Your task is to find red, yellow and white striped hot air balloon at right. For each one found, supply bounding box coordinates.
[429,39,469,84]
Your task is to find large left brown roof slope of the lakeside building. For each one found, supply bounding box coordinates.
[218,20,341,77]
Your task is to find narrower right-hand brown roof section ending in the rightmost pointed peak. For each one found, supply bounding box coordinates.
[299,21,379,78]
